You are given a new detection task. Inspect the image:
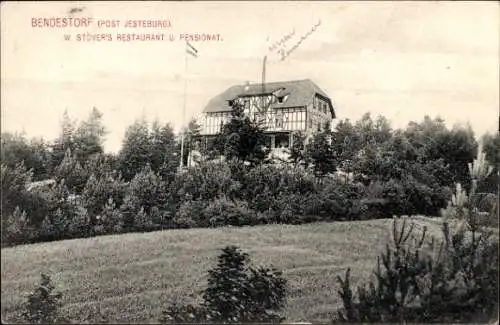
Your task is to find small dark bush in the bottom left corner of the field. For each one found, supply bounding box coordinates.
[22,273,62,324]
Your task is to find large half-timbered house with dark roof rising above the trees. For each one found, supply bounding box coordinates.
[191,79,335,165]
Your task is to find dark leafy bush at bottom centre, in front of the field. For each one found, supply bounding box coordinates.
[161,246,286,323]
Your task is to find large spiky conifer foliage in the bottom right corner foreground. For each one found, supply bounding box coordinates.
[337,146,498,323]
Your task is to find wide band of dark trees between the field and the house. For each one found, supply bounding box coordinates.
[1,107,499,246]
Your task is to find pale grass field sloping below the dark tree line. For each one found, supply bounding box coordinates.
[1,217,439,323]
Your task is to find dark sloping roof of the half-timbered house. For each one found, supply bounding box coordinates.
[203,79,335,117]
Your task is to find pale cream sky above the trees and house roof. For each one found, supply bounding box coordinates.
[1,1,500,152]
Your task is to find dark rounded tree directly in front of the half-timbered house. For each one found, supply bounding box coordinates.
[215,103,270,165]
